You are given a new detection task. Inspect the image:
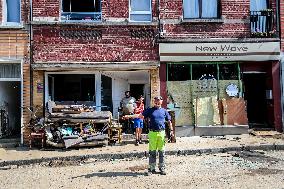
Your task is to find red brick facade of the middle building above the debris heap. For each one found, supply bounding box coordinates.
[25,0,160,143]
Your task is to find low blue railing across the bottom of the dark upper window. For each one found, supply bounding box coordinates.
[61,12,102,22]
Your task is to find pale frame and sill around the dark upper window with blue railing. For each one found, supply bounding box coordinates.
[60,0,103,22]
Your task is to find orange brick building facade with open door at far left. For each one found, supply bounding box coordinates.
[0,0,30,142]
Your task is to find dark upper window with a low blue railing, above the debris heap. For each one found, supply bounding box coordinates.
[61,0,102,21]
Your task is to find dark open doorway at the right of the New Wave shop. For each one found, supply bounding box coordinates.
[243,73,271,128]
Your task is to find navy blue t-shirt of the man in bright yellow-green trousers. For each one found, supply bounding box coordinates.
[142,107,171,130]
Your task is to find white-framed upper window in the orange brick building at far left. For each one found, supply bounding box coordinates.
[2,0,21,25]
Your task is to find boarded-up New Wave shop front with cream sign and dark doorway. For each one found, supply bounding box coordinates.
[160,42,281,135]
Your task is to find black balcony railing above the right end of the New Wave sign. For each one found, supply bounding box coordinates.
[250,9,277,38]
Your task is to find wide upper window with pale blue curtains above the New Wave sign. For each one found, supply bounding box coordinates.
[183,0,220,19]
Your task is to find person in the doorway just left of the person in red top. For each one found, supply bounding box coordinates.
[120,91,136,133]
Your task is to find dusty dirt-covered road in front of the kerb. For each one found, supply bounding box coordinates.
[0,151,284,189]
